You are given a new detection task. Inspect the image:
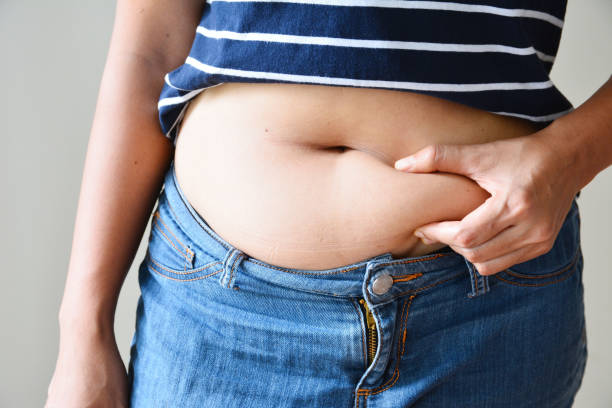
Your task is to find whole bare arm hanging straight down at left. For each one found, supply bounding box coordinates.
[48,0,204,406]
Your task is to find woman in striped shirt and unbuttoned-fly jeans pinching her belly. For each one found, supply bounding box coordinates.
[47,0,612,408]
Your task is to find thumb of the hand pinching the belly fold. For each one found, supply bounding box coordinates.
[395,144,478,175]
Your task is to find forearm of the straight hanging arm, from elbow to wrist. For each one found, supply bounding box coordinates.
[60,53,174,335]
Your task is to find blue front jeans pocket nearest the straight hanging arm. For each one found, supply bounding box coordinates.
[145,192,222,281]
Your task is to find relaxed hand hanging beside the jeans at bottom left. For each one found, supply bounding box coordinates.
[45,335,129,408]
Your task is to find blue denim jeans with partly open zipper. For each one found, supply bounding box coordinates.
[129,163,587,408]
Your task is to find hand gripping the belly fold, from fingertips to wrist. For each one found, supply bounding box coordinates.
[395,134,579,275]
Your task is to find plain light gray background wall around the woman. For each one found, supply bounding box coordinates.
[0,0,612,408]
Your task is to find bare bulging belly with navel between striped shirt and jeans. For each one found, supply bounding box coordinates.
[174,83,538,270]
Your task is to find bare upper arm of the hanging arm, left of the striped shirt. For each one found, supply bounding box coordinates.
[109,0,205,72]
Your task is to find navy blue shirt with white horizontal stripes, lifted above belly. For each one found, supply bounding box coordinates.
[158,0,574,144]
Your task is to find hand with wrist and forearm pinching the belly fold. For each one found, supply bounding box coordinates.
[395,77,612,275]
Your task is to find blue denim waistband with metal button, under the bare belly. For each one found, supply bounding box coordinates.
[160,161,571,305]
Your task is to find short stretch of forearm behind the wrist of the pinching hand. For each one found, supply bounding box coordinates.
[539,76,612,191]
